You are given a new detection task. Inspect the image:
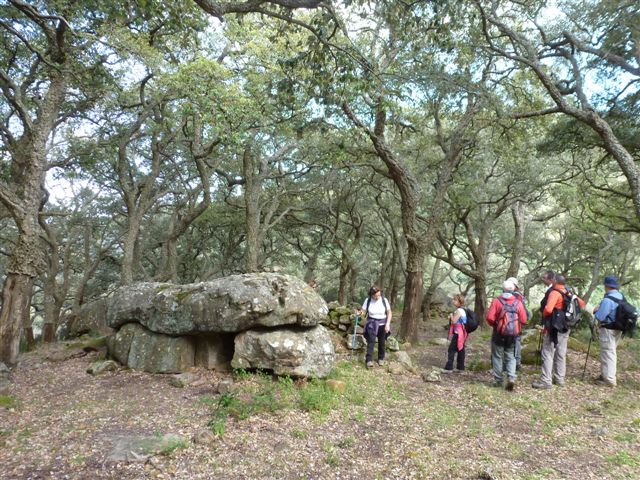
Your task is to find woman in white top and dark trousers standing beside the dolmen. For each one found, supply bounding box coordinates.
[358,285,391,368]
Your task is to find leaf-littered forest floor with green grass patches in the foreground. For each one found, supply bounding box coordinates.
[0,318,640,480]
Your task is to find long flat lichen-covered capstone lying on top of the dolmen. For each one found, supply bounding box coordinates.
[107,273,328,335]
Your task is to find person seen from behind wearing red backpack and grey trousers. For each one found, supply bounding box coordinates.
[486,280,527,391]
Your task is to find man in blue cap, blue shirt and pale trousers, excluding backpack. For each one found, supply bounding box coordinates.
[593,276,624,387]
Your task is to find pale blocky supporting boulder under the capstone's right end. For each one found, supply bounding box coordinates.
[231,325,335,378]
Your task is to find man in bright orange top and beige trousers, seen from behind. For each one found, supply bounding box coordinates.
[531,274,585,390]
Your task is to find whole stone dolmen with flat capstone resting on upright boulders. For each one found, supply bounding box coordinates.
[106,273,335,377]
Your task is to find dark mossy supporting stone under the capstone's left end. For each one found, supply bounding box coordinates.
[108,323,195,373]
